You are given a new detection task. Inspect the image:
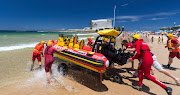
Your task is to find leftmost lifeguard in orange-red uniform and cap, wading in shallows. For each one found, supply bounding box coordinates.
[30,41,45,71]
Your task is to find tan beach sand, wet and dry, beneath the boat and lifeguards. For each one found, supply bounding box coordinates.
[0,36,180,95]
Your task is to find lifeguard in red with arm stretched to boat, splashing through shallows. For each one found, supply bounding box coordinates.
[44,42,66,84]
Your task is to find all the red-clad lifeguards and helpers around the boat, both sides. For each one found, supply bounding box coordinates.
[31,34,180,95]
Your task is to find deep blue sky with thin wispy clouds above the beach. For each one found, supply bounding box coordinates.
[0,0,180,31]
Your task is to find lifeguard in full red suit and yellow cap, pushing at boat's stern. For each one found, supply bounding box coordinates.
[128,35,172,95]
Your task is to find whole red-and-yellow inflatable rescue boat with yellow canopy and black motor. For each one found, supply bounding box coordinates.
[54,29,127,81]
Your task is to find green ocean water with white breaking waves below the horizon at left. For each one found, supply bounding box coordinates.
[0,30,97,51]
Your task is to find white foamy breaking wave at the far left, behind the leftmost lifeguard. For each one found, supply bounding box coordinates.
[0,42,38,51]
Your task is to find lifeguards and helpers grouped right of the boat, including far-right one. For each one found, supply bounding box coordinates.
[121,34,180,95]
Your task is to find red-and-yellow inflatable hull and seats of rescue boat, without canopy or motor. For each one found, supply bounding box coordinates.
[54,35,109,78]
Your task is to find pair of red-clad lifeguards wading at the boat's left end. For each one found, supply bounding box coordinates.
[30,40,66,84]
